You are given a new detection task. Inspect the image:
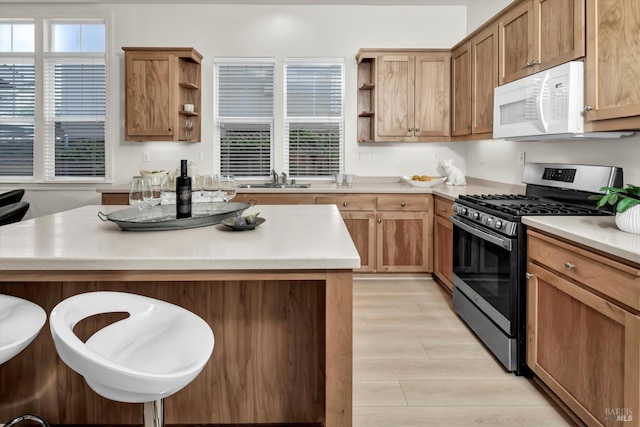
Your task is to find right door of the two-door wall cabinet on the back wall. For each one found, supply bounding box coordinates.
[416,53,451,138]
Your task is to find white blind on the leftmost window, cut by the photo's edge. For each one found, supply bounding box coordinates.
[0,58,35,177]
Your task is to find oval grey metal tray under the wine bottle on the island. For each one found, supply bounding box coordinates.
[98,202,250,231]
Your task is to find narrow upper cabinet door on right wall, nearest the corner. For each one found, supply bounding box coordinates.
[451,43,472,136]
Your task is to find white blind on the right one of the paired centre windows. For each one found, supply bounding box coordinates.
[284,60,344,177]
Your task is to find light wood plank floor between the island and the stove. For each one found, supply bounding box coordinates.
[353,277,574,427]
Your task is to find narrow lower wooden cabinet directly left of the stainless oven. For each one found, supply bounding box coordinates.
[433,197,453,291]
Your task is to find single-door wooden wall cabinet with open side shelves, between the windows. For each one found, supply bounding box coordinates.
[122,47,202,141]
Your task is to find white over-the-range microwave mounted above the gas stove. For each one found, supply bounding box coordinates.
[493,61,632,141]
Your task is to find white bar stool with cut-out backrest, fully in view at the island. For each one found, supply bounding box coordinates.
[49,292,214,427]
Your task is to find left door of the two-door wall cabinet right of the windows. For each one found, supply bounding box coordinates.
[376,55,415,139]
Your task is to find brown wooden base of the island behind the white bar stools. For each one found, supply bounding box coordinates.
[0,271,352,426]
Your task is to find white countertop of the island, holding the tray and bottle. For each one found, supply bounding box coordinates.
[0,205,360,271]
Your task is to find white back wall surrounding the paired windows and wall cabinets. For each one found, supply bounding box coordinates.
[2,3,466,216]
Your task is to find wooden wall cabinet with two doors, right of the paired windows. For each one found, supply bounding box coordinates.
[357,49,451,142]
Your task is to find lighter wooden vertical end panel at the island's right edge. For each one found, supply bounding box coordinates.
[325,272,353,427]
